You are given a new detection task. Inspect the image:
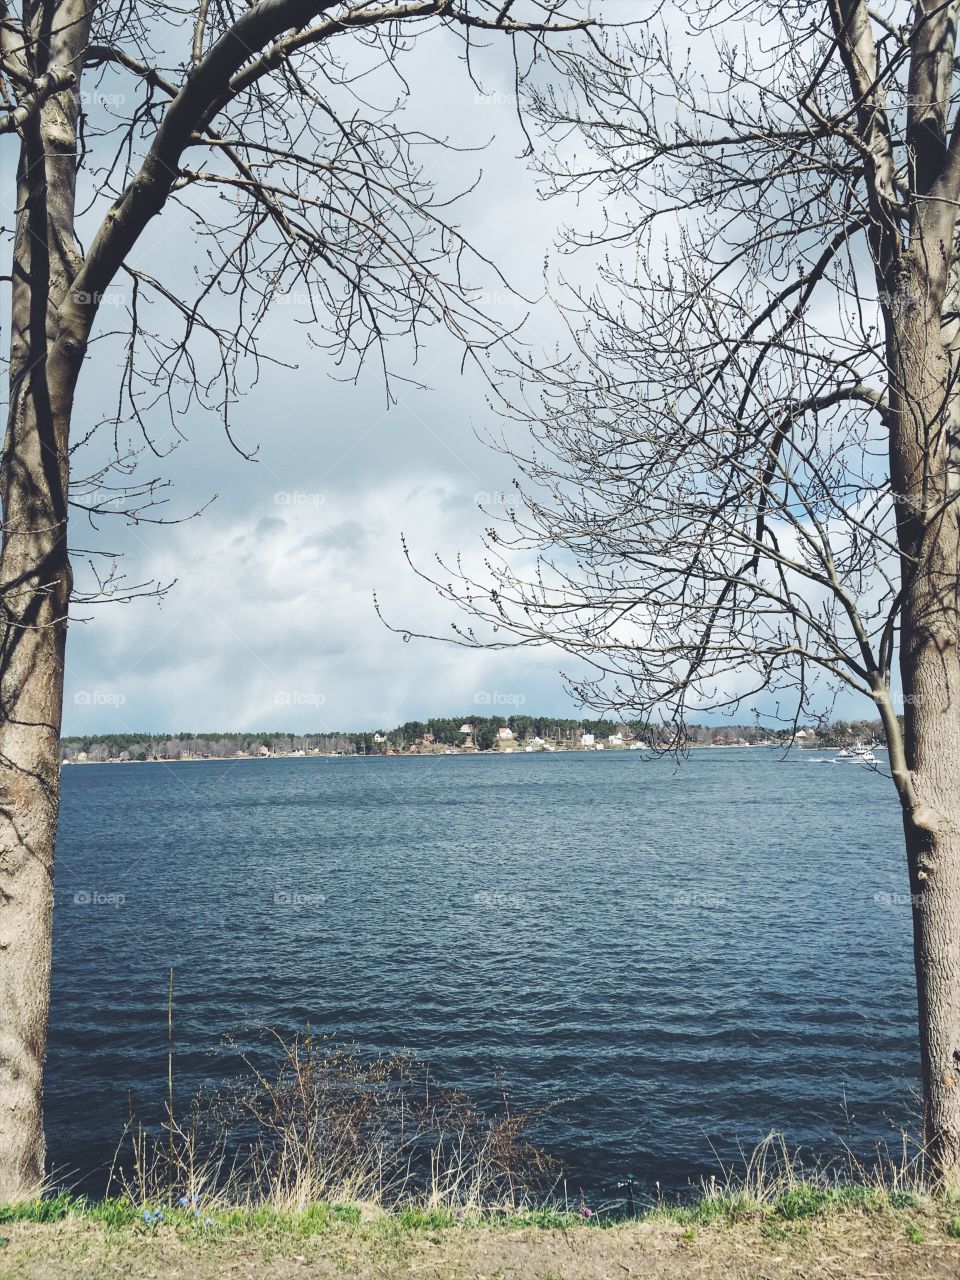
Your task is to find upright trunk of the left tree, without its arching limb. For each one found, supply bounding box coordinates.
[0,10,90,1201]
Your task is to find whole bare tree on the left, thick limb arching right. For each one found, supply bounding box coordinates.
[0,0,594,1201]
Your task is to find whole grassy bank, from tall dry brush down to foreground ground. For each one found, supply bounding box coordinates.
[0,1131,960,1280]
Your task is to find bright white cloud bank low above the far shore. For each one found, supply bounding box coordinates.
[64,474,583,733]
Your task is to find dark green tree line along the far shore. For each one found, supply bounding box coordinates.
[60,716,883,762]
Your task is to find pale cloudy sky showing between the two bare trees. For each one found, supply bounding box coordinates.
[48,5,885,735]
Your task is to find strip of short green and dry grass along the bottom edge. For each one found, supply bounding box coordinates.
[7,1184,960,1280]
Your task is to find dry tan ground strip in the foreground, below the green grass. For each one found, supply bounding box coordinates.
[0,1216,960,1280]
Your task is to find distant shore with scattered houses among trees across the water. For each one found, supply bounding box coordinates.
[60,716,883,764]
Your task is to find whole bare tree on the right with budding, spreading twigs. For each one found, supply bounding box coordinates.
[396,0,960,1187]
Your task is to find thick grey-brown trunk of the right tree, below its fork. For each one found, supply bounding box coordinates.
[888,252,960,1189]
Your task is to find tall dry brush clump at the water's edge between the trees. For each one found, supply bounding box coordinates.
[111,1033,558,1212]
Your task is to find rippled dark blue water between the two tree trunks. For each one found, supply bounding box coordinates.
[46,750,919,1192]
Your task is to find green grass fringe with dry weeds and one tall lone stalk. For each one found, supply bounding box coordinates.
[9,1018,960,1259]
